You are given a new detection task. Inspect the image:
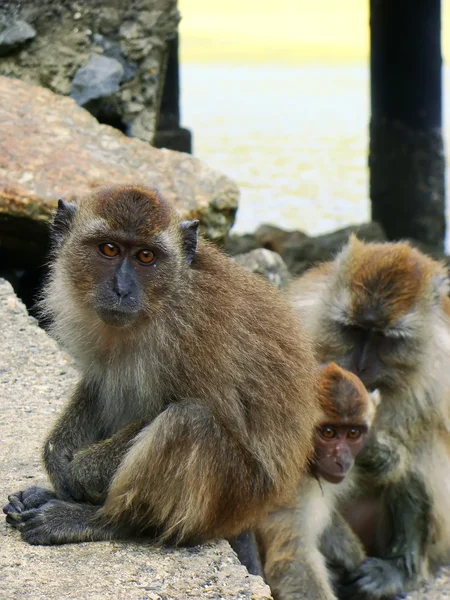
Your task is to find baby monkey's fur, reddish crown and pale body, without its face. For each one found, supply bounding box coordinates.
[258,363,375,600]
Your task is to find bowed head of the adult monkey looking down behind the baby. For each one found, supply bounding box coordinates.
[316,240,448,394]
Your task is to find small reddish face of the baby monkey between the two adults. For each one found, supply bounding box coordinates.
[314,422,367,483]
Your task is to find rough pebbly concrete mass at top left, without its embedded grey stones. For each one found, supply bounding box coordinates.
[0,0,180,143]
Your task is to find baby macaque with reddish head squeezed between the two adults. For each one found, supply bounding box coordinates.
[258,363,379,600]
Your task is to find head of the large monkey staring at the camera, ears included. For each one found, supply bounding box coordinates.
[49,187,198,327]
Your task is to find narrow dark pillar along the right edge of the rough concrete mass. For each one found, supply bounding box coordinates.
[153,36,192,154]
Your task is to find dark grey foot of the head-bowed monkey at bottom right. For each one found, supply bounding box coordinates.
[340,558,404,600]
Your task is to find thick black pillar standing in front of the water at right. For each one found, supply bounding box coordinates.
[369,0,445,250]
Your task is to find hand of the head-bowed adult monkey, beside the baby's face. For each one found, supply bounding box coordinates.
[356,434,409,482]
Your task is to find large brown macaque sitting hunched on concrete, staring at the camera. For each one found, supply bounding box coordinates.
[4,186,318,544]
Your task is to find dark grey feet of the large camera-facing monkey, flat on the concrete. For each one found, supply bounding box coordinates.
[7,499,112,545]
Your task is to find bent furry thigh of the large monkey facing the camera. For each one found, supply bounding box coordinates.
[100,401,278,544]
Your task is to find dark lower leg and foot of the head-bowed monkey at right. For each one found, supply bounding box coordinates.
[342,476,431,598]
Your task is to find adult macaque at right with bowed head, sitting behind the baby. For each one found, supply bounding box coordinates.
[291,237,450,598]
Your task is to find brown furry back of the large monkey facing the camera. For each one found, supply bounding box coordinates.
[175,242,318,504]
